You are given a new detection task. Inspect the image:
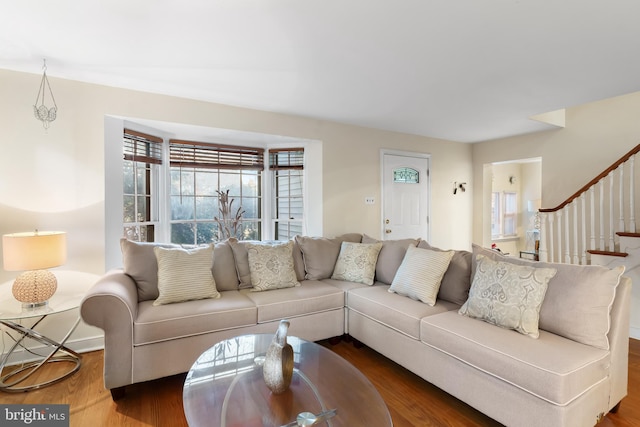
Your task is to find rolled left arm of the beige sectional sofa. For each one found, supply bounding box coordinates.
[80,270,138,389]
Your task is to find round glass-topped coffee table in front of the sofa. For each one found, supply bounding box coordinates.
[183,334,393,427]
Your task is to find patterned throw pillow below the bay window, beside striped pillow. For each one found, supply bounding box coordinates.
[246,241,300,292]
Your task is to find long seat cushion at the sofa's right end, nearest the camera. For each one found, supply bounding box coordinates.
[420,312,610,406]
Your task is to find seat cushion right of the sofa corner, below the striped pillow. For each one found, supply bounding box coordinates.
[347,282,460,340]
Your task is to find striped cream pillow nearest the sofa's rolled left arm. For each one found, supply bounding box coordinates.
[153,245,220,305]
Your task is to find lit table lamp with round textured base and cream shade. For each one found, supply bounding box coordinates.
[2,230,67,308]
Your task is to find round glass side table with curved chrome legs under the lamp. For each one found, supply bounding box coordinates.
[0,271,99,392]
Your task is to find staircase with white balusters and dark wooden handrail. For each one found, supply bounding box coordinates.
[539,144,640,339]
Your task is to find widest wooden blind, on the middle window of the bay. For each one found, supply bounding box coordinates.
[169,139,264,170]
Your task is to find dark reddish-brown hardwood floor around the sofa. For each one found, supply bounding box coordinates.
[0,340,640,427]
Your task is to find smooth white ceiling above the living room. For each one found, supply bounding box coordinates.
[0,0,640,142]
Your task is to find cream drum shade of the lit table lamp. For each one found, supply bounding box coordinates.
[2,231,67,271]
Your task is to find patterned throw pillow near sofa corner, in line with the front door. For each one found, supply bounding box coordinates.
[331,242,382,285]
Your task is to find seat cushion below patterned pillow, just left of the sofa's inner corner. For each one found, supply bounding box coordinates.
[241,280,345,323]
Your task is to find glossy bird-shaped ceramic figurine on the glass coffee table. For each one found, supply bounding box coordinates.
[262,320,293,394]
